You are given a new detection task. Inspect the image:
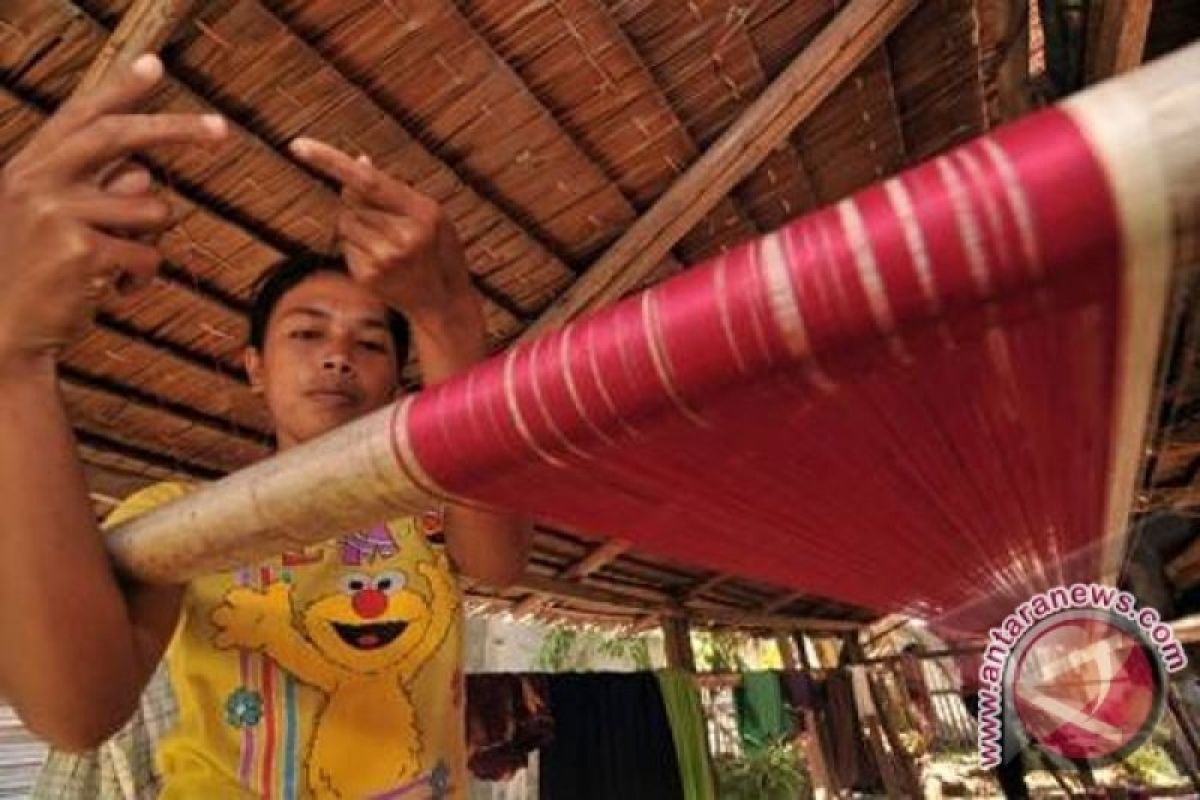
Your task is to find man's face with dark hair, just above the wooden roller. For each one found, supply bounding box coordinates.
[246,272,398,450]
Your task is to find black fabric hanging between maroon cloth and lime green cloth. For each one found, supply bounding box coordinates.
[539,673,684,800]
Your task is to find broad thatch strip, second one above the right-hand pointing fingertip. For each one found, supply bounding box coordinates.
[262,0,634,265]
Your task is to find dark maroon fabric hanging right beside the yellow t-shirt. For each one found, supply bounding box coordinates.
[467,674,554,781]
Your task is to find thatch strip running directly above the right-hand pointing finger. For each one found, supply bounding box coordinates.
[165,0,574,319]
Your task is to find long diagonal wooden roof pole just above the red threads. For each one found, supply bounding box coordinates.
[523,0,917,338]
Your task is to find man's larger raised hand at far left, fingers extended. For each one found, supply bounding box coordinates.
[0,55,227,368]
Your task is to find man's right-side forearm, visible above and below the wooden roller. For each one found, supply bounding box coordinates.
[412,297,533,588]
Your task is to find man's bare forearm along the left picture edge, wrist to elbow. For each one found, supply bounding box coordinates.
[0,356,150,748]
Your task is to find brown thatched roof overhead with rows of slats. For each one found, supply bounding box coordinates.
[0,0,1200,627]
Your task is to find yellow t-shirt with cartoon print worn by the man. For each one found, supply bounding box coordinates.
[108,483,467,800]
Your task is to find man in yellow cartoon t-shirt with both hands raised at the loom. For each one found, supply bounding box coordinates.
[0,55,529,798]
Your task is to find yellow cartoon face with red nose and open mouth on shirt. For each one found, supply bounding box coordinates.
[304,571,432,673]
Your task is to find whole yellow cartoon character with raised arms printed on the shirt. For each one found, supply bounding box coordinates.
[212,529,458,798]
